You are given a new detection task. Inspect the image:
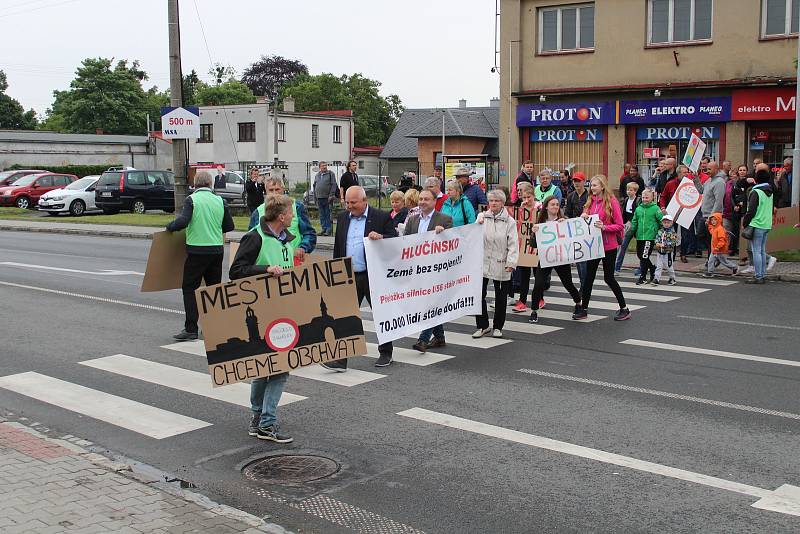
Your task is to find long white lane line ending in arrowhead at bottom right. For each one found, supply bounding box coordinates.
[397,408,800,516]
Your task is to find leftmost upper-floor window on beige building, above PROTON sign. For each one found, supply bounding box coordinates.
[539,3,594,53]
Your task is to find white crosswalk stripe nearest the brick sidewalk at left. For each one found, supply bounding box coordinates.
[0,372,211,439]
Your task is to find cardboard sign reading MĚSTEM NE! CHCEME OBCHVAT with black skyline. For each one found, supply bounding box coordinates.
[195,258,367,387]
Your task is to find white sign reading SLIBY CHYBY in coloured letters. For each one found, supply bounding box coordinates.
[536,215,605,267]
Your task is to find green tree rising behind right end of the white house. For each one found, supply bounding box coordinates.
[280,73,403,146]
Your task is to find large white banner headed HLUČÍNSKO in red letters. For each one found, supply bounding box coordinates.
[364,224,483,343]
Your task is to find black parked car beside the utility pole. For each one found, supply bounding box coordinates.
[94,169,175,214]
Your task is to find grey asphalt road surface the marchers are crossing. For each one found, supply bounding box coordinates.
[0,232,800,533]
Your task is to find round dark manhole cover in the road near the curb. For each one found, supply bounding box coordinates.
[242,455,339,484]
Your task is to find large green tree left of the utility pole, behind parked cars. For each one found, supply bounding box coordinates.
[45,58,158,134]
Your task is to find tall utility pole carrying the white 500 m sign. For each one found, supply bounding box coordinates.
[167,0,189,211]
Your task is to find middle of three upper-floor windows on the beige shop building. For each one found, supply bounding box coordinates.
[647,0,713,45]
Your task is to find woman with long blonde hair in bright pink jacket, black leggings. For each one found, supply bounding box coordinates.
[572,174,631,321]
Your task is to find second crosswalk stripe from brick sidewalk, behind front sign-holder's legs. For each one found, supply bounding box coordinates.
[80,354,307,408]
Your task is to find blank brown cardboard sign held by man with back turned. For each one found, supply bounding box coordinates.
[139,230,186,293]
